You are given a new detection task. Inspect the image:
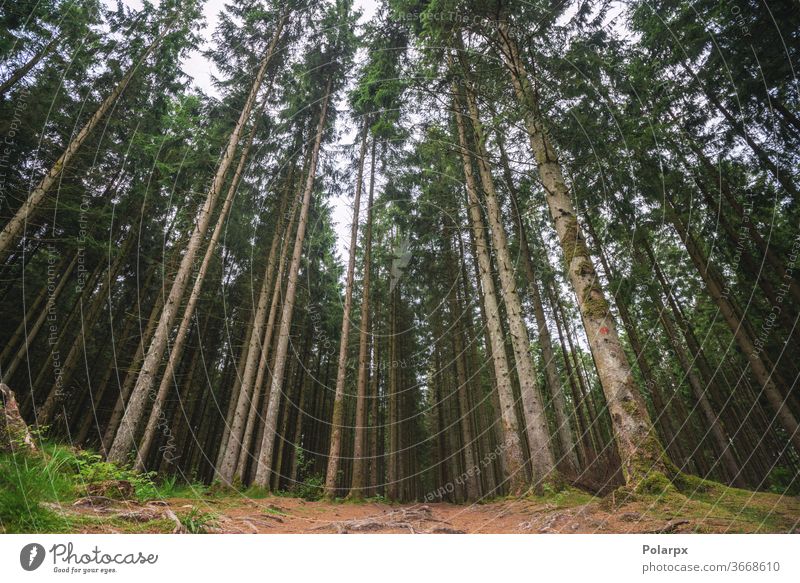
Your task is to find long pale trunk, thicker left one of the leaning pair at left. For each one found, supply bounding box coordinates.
[108,14,287,462]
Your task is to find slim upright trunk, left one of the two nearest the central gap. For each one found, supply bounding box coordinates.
[325,120,375,498]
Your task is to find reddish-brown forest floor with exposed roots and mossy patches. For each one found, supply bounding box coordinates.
[51,484,800,534]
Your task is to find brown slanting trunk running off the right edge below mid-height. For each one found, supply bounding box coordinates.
[671,212,800,452]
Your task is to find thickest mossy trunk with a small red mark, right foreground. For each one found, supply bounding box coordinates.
[497,23,674,487]
